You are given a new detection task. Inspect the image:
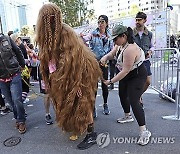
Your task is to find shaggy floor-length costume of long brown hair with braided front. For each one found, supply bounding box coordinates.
[36,3,101,134]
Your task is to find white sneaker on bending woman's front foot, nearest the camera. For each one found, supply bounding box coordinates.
[138,130,151,145]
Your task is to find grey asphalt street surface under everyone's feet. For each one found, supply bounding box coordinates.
[0,84,180,154]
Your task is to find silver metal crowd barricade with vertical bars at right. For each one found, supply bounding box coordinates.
[151,48,180,120]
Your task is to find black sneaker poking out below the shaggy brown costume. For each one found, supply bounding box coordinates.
[77,132,97,150]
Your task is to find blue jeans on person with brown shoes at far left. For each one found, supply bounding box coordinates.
[0,73,26,122]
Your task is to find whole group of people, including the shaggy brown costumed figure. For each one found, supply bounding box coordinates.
[0,3,154,150]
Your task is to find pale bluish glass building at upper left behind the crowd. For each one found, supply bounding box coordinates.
[0,0,48,34]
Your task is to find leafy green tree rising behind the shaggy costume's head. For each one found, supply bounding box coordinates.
[49,0,94,27]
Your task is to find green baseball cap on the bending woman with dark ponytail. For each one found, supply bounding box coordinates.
[110,25,127,40]
